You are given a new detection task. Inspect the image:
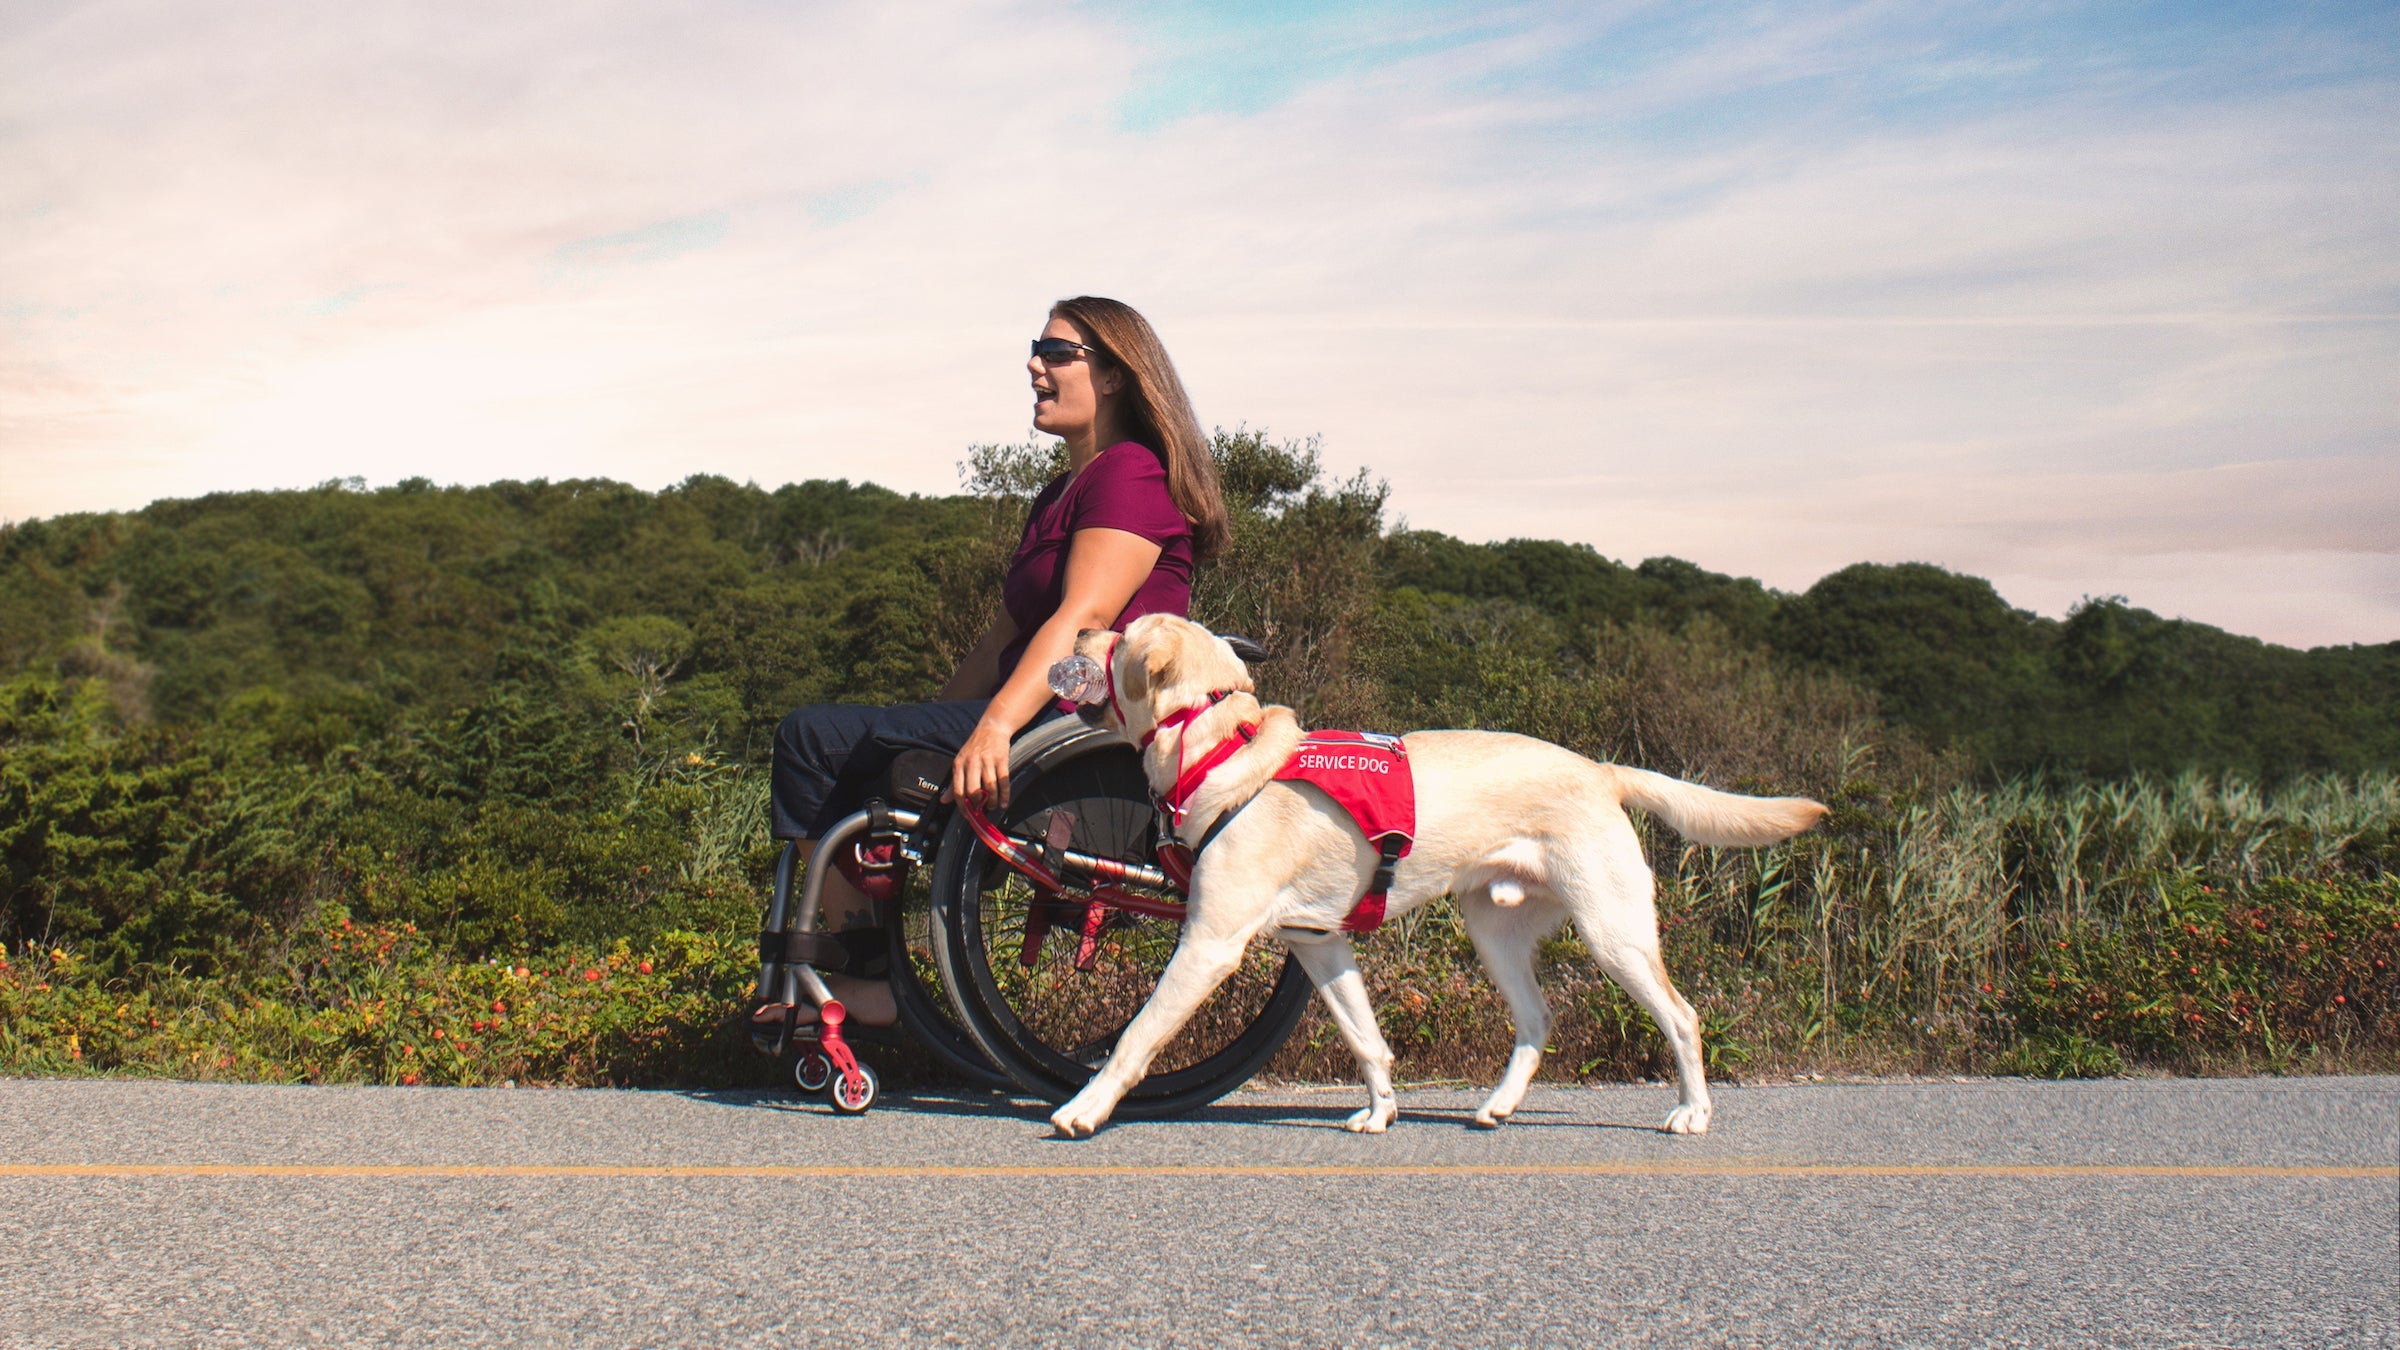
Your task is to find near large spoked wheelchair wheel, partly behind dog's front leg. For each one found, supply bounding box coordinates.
[931,723,1310,1117]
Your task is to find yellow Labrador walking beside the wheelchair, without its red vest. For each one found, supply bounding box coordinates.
[1051,615,1824,1139]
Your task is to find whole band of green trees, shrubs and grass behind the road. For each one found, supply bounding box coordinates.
[0,428,2400,1081]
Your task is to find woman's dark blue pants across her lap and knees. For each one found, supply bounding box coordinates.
[768,699,1058,838]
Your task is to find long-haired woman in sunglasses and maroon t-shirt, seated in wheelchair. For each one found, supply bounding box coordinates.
[756,295,1226,1026]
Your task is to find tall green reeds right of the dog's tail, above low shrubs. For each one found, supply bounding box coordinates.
[1649,773,2400,1014]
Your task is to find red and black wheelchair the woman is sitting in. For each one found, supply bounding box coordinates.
[754,639,1313,1117]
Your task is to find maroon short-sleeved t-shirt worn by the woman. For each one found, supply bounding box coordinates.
[1001,440,1193,682]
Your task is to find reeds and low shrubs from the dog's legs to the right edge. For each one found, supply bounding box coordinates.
[1279,773,2400,1076]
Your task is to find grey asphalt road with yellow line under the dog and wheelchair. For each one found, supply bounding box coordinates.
[0,1079,2400,1348]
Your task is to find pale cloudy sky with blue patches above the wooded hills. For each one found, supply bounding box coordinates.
[0,0,2400,646]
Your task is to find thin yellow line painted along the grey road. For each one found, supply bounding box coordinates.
[0,1163,2400,1182]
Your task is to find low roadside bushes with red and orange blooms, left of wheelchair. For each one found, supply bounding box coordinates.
[0,908,770,1086]
